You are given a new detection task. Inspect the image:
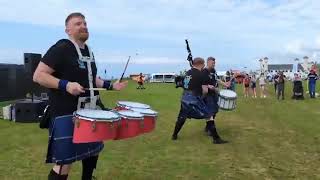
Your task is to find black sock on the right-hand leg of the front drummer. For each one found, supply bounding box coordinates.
[81,156,98,180]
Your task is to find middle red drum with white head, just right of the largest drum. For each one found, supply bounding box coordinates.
[115,110,143,140]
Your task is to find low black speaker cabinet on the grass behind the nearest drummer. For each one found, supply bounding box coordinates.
[13,99,47,123]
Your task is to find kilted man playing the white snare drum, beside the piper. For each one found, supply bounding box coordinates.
[202,57,230,144]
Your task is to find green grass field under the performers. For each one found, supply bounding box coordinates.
[0,82,320,180]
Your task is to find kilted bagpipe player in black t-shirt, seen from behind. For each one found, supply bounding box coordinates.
[172,57,227,144]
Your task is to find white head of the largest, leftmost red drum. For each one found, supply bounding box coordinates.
[76,109,120,121]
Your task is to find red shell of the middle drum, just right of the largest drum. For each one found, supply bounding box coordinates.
[115,115,143,140]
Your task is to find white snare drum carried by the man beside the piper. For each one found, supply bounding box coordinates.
[218,89,237,110]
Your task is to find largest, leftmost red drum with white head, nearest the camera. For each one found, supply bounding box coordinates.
[73,109,120,143]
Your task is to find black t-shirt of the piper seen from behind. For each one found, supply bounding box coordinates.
[184,68,204,96]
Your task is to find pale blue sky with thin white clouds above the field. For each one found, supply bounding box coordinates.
[0,0,320,77]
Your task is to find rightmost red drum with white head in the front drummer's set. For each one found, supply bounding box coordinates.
[131,108,158,133]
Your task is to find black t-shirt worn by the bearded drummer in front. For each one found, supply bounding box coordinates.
[41,39,98,117]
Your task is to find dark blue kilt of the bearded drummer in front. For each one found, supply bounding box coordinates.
[46,115,104,165]
